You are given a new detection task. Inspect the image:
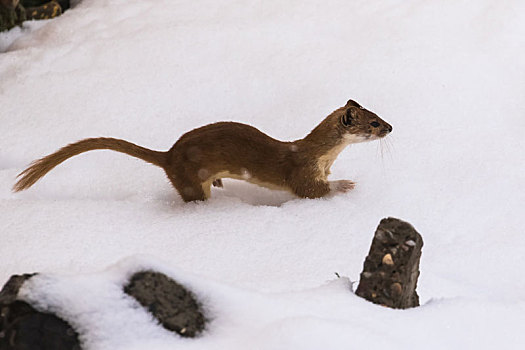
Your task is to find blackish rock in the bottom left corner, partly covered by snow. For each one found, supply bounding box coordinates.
[0,274,80,350]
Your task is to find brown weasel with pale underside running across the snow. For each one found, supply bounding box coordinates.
[13,100,392,202]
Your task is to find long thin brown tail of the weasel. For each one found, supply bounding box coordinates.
[13,137,167,192]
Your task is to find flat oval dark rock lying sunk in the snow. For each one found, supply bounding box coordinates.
[124,271,206,337]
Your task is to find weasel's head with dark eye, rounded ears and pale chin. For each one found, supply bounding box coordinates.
[334,100,392,143]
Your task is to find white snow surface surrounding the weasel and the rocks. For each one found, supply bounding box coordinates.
[0,0,525,349]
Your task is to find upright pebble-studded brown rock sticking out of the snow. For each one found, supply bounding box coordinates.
[356,218,423,309]
